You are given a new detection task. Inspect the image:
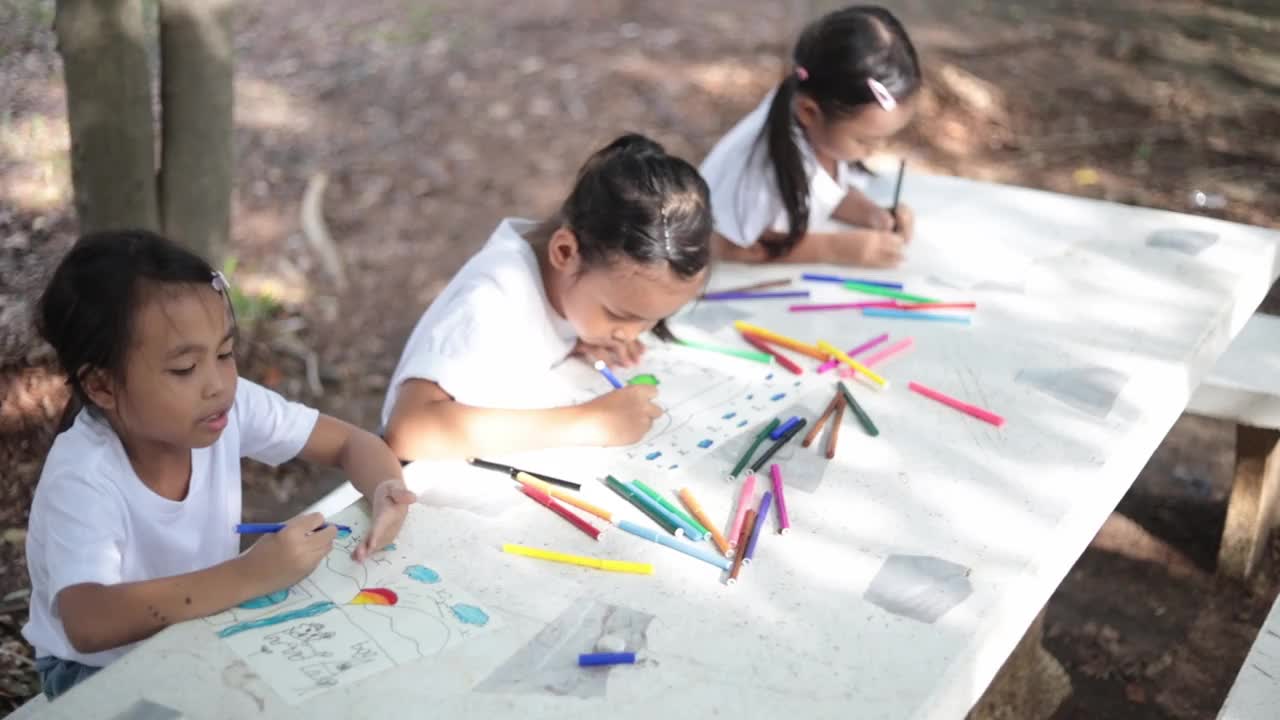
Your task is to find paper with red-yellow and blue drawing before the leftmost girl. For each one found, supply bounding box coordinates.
[205,505,498,705]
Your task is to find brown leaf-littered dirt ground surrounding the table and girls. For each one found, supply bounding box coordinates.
[0,0,1280,720]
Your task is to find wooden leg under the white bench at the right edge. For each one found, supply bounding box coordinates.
[1217,425,1280,580]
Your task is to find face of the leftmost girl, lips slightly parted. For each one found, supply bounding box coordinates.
[86,286,237,450]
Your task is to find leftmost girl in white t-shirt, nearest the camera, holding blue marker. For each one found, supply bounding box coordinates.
[23,231,416,697]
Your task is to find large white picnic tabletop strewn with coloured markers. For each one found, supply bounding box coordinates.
[35,174,1280,720]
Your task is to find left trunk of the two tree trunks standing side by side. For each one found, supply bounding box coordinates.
[54,0,160,233]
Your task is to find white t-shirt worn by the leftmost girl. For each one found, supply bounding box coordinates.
[22,378,319,666]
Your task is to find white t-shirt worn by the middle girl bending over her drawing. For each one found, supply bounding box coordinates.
[383,218,577,428]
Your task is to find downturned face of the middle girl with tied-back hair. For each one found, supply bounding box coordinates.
[544,228,707,347]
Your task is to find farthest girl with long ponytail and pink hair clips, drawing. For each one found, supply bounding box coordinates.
[700,6,920,266]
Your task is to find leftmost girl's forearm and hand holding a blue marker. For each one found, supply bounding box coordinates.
[55,512,337,653]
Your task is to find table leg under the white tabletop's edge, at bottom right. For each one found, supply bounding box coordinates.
[968,610,1071,720]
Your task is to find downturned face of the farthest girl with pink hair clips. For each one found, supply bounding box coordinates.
[795,95,914,163]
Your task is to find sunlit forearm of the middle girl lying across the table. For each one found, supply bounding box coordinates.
[385,379,662,460]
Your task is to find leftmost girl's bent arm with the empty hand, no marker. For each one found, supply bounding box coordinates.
[298,414,417,560]
